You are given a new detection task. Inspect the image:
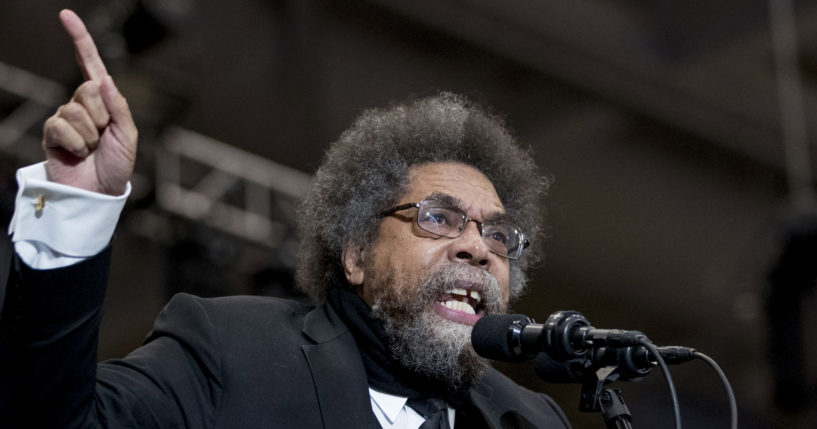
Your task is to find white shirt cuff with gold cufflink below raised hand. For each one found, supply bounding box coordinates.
[9,162,131,269]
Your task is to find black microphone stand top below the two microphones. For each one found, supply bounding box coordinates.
[579,366,633,429]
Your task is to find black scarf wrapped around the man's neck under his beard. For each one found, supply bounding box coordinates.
[327,288,468,408]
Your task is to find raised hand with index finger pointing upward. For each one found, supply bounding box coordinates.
[43,9,138,195]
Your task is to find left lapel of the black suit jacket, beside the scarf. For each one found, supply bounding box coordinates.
[301,305,379,429]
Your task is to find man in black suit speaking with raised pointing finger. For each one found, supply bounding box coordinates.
[0,11,569,428]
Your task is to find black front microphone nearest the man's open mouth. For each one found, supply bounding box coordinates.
[471,311,647,362]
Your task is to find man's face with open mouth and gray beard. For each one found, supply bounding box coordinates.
[347,163,509,385]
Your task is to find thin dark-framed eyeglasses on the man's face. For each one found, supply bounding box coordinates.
[380,199,530,259]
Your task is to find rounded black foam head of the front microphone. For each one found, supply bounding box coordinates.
[471,314,533,362]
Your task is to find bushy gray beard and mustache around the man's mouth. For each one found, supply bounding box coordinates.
[370,264,506,390]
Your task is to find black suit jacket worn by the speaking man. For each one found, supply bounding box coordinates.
[0,246,569,428]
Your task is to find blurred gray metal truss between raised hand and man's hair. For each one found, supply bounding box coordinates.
[156,127,312,248]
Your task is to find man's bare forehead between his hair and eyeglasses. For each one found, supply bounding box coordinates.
[404,162,505,215]
